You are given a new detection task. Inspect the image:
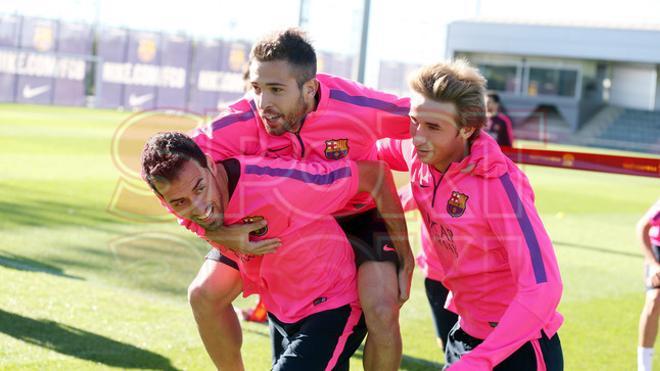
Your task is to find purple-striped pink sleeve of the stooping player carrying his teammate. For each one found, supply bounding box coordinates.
[241,157,359,218]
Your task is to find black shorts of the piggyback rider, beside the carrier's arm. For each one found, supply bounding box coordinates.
[337,208,399,267]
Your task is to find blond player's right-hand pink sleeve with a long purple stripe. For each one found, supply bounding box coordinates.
[450,173,562,370]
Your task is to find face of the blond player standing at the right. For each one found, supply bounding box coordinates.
[410,94,466,166]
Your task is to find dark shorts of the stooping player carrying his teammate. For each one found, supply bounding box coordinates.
[268,305,367,371]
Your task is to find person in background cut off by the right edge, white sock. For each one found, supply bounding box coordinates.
[637,199,660,371]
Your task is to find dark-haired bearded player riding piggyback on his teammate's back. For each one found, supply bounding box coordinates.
[189,29,414,371]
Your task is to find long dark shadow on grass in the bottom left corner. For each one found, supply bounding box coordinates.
[0,309,176,370]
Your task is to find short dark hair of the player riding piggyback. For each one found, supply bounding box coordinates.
[250,28,316,87]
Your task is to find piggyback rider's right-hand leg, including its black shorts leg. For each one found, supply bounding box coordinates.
[338,209,402,371]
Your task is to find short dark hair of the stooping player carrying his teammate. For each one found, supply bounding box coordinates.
[141,131,208,194]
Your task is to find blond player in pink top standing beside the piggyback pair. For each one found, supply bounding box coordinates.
[379,60,563,371]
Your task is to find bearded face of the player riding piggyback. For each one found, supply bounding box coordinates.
[250,60,309,135]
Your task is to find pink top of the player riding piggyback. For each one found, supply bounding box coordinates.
[194,74,410,214]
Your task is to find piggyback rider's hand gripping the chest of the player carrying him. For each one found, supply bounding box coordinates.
[205,220,282,255]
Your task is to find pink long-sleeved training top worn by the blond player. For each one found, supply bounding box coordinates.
[378,133,563,370]
